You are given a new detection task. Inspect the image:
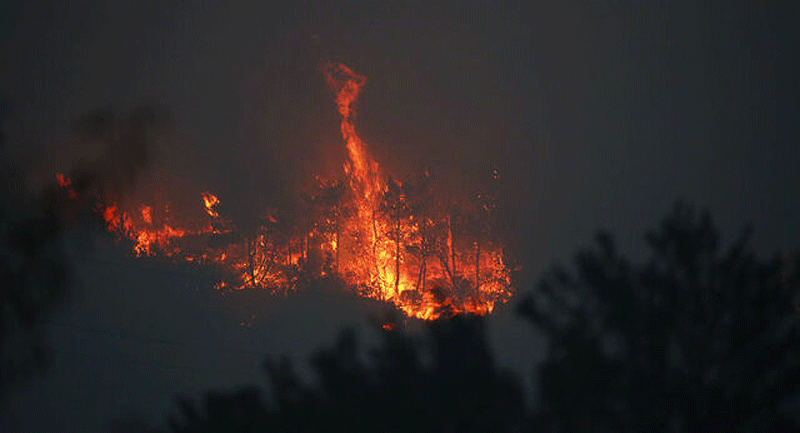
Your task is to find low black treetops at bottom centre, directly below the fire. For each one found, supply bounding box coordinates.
[171,318,524,432]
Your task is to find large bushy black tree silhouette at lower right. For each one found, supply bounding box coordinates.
[519,204,800,432]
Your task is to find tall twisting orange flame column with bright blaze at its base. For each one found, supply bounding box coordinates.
[316,63,511,319]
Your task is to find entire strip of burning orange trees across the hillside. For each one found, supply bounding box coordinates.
[57,63,511,320]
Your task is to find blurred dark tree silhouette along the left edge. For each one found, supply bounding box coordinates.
[0,102,71,402]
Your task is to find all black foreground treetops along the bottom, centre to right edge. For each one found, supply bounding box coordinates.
[162,205,800,432]
